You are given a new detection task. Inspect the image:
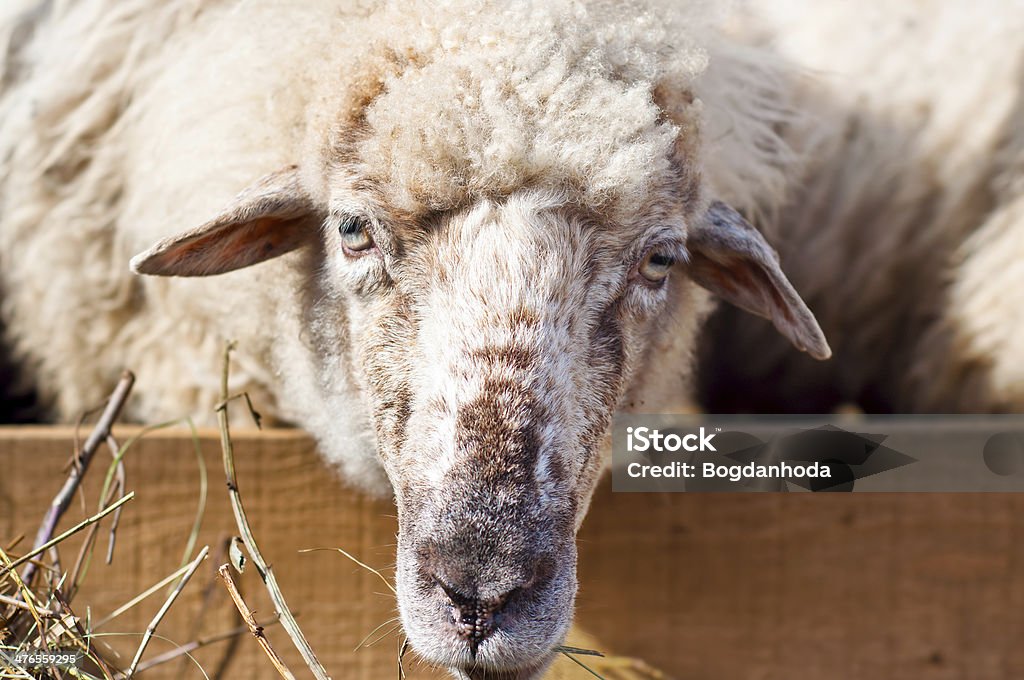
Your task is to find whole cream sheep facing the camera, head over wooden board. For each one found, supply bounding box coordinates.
[0,0,829,679]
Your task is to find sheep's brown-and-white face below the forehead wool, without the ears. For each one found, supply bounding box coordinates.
[322,193,687,677]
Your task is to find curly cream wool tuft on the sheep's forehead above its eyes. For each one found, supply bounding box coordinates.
[331,0,707,215]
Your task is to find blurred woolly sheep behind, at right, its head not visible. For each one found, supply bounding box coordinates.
[698,0,1024,413]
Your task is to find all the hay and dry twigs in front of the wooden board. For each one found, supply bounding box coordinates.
[0,344,664,680]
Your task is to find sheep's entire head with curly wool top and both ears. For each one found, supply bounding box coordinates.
[133,3,828,679]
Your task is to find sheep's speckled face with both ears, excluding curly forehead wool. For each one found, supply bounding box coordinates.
[133,161,827,678]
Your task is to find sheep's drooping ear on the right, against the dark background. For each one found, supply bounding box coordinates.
[686,201,831,359]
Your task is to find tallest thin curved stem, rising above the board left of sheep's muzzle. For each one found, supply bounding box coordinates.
[217,342,331,680]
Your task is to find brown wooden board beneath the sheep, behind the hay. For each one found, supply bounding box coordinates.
[0,428,1024,680]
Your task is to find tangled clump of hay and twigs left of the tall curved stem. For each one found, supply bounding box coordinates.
[0,373,276,680]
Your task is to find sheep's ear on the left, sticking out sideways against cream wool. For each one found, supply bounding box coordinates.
[131,166,319,277]
